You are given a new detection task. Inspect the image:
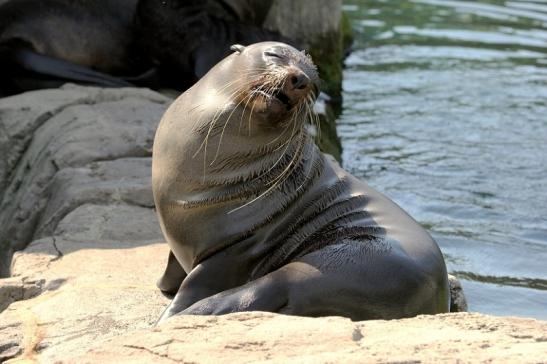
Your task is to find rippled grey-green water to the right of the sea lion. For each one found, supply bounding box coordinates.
[338,0,547,319]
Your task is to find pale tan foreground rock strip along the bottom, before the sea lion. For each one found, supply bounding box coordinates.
[41,313,547,363]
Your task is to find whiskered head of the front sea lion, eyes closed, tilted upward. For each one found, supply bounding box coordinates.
[202,42,320,131]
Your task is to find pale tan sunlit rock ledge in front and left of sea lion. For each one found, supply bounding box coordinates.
[0,228,547,363]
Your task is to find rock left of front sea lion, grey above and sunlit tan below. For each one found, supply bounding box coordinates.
[0,86,170,362]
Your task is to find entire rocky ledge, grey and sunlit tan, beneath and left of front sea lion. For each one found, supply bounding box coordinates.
[0,87,547,363]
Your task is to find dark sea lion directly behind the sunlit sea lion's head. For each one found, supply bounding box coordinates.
[136,0,295,89]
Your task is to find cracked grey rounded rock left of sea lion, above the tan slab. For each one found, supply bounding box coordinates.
[0,85,171,276]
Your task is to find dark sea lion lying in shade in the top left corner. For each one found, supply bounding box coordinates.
[0,0,158,95]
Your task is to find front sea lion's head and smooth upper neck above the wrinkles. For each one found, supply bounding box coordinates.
[154,42,320,191]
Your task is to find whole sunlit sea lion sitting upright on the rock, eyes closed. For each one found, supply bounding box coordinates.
[152,42,449,322]
